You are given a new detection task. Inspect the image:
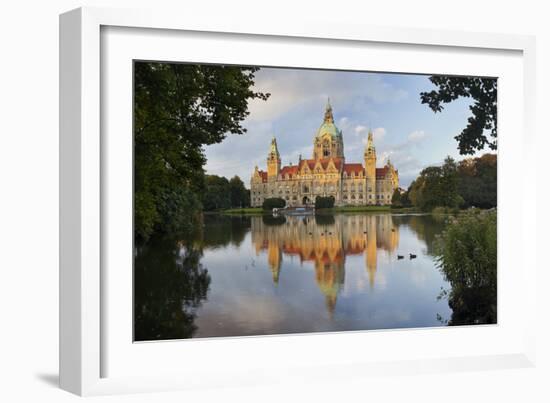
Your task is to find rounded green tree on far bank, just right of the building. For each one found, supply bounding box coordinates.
[408,157,464,211]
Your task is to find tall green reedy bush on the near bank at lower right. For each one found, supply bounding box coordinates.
[436,209,497,325]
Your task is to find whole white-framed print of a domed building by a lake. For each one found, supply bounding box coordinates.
[60,9,536,394]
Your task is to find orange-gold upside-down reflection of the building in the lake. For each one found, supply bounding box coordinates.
[251,214,399,314]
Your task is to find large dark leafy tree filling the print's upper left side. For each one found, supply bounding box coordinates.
[134,62,269,239]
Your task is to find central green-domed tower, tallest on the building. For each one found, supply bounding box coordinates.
[313,99,344,160]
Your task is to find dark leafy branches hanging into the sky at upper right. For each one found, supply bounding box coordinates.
[420,76,497,154]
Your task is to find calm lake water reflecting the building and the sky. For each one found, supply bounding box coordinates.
[135,213,451,340]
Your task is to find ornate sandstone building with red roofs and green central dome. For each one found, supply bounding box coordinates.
[250,102,399,207]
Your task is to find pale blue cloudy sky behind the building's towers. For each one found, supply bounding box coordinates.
[205,68,490,188]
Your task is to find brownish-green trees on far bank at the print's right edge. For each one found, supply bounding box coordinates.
[458,154,497,208]
